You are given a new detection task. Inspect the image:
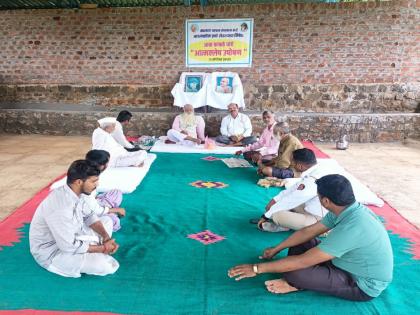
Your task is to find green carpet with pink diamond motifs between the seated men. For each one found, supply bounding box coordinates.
[0,154,420,315]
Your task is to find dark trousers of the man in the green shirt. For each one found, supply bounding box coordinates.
[283,239,373,301]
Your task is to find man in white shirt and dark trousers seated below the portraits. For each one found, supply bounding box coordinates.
[216,103,257,146]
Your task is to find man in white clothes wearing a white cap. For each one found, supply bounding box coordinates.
[92,117,147,167]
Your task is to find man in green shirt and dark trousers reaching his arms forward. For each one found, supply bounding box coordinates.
[228,175,393,301]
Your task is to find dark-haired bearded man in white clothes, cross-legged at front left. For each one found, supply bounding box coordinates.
[29,160,119,278]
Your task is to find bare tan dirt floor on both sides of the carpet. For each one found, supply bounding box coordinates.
[0,134,420,227]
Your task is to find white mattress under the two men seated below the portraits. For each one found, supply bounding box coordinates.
[150,140,243,154]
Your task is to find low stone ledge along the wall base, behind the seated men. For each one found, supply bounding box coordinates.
[0,103,420,142]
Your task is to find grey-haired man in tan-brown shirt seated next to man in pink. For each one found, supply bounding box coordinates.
[258,122,303,178]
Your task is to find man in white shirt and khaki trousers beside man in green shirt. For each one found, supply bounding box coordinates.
[258,148,331,232]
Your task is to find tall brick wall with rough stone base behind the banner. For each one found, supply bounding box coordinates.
[0,0,420,112]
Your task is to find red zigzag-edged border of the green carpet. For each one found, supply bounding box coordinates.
[0,140,420,315]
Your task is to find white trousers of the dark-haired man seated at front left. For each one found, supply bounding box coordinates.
[47,216,120,278]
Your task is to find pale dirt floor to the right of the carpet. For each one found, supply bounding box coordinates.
[317,141,420,228]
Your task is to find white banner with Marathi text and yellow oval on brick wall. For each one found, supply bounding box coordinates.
[185,19,254,68]
